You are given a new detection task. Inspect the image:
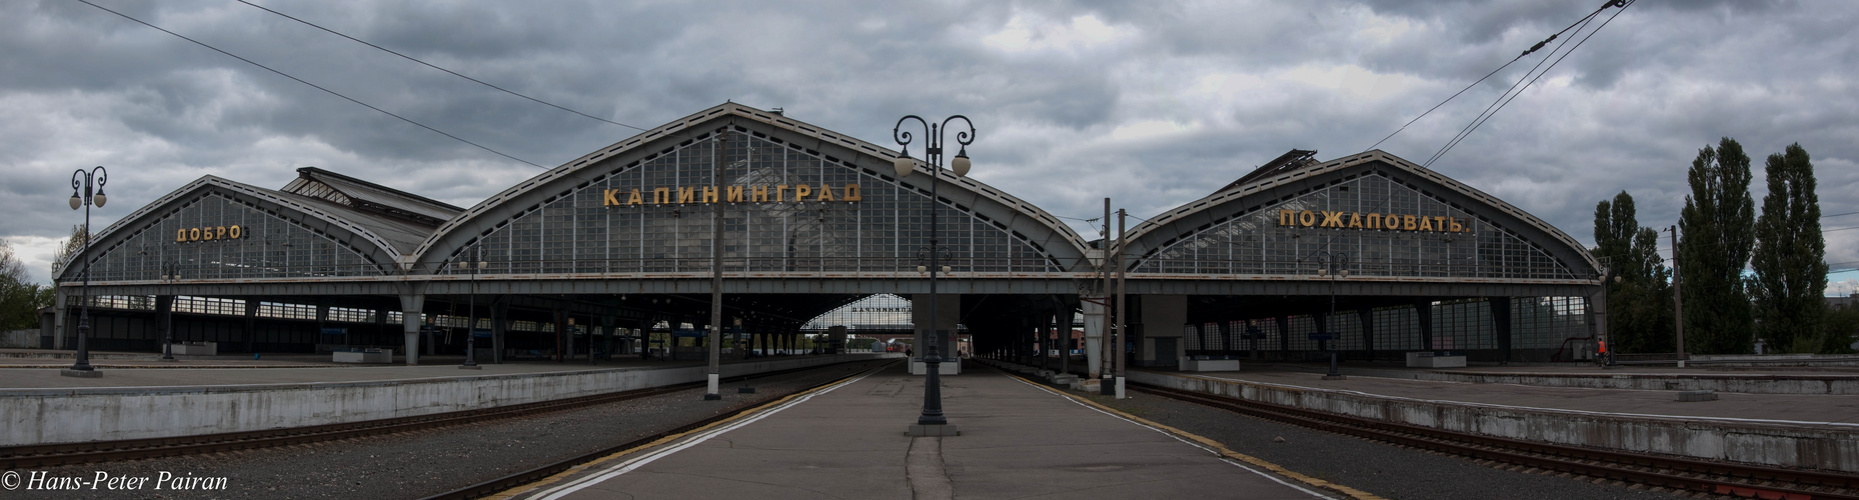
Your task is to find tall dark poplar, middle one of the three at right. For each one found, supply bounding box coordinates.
[1677,138,1755,353]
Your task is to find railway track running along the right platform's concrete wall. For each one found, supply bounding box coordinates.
[1130,383,1859,500]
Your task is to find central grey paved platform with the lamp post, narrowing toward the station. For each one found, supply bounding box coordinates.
[500,364,1342,498]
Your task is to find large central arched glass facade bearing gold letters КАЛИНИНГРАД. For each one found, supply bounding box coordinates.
[446,128,1061,273]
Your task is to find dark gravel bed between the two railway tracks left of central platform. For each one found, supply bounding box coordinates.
[0,361,883,498]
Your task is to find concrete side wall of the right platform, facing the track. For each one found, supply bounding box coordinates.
[1128,370,1859,472]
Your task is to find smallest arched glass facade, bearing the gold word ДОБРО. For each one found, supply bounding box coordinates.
[81,191,383,281]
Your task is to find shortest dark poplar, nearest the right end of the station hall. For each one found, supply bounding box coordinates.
[1595,191,1675,353]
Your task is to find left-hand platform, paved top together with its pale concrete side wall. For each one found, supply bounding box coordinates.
[0,353,902,446]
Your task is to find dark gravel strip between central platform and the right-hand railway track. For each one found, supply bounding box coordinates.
[1069,377,1687,500]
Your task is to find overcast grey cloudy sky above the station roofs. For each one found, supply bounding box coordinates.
[0,0,1859,294]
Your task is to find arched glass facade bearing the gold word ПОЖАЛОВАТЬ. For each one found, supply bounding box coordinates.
[1132,169,1576,279]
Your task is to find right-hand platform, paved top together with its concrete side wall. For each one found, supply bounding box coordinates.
[1128,364,1859,472]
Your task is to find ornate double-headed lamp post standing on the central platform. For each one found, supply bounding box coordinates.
[890,115,974,437]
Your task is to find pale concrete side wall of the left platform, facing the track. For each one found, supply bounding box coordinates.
[0,353,887,446]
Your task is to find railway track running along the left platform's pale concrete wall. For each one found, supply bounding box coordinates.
[0,362,884,470]
